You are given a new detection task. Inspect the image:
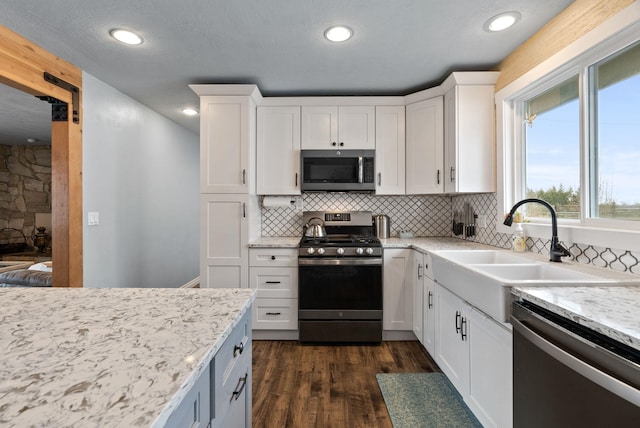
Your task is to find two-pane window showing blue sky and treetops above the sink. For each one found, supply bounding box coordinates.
[514,38,640,228]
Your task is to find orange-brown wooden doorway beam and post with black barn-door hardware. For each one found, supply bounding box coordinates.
[0,25,82,287]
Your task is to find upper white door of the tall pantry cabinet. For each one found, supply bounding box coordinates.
[200,96,255,193]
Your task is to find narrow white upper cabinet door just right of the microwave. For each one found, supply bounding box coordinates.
[376,106,405,195]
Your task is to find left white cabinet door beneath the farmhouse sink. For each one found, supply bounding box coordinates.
[435,284,471,397]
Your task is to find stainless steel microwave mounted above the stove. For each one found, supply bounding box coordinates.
[300,150,376,192]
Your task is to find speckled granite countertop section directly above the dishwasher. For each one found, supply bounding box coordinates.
[511,285,640,350]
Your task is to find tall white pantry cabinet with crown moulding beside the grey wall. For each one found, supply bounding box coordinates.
[190,85,260,288]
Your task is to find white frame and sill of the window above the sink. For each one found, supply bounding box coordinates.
[496,13,640,251]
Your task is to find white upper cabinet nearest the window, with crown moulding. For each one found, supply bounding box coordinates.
[444,73,497,193]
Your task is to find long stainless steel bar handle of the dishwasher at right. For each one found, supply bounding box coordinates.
[511,316,640,406]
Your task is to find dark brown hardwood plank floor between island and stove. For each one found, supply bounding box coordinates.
[252,340,440,428]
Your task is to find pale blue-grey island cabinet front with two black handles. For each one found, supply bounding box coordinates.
[211,312,251,426]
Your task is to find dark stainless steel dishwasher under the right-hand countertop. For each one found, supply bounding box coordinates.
[511,301,640,428]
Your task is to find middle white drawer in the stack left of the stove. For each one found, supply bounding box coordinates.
[249,267,298,299]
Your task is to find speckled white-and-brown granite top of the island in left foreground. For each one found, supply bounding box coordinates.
[0,288,255,427]
